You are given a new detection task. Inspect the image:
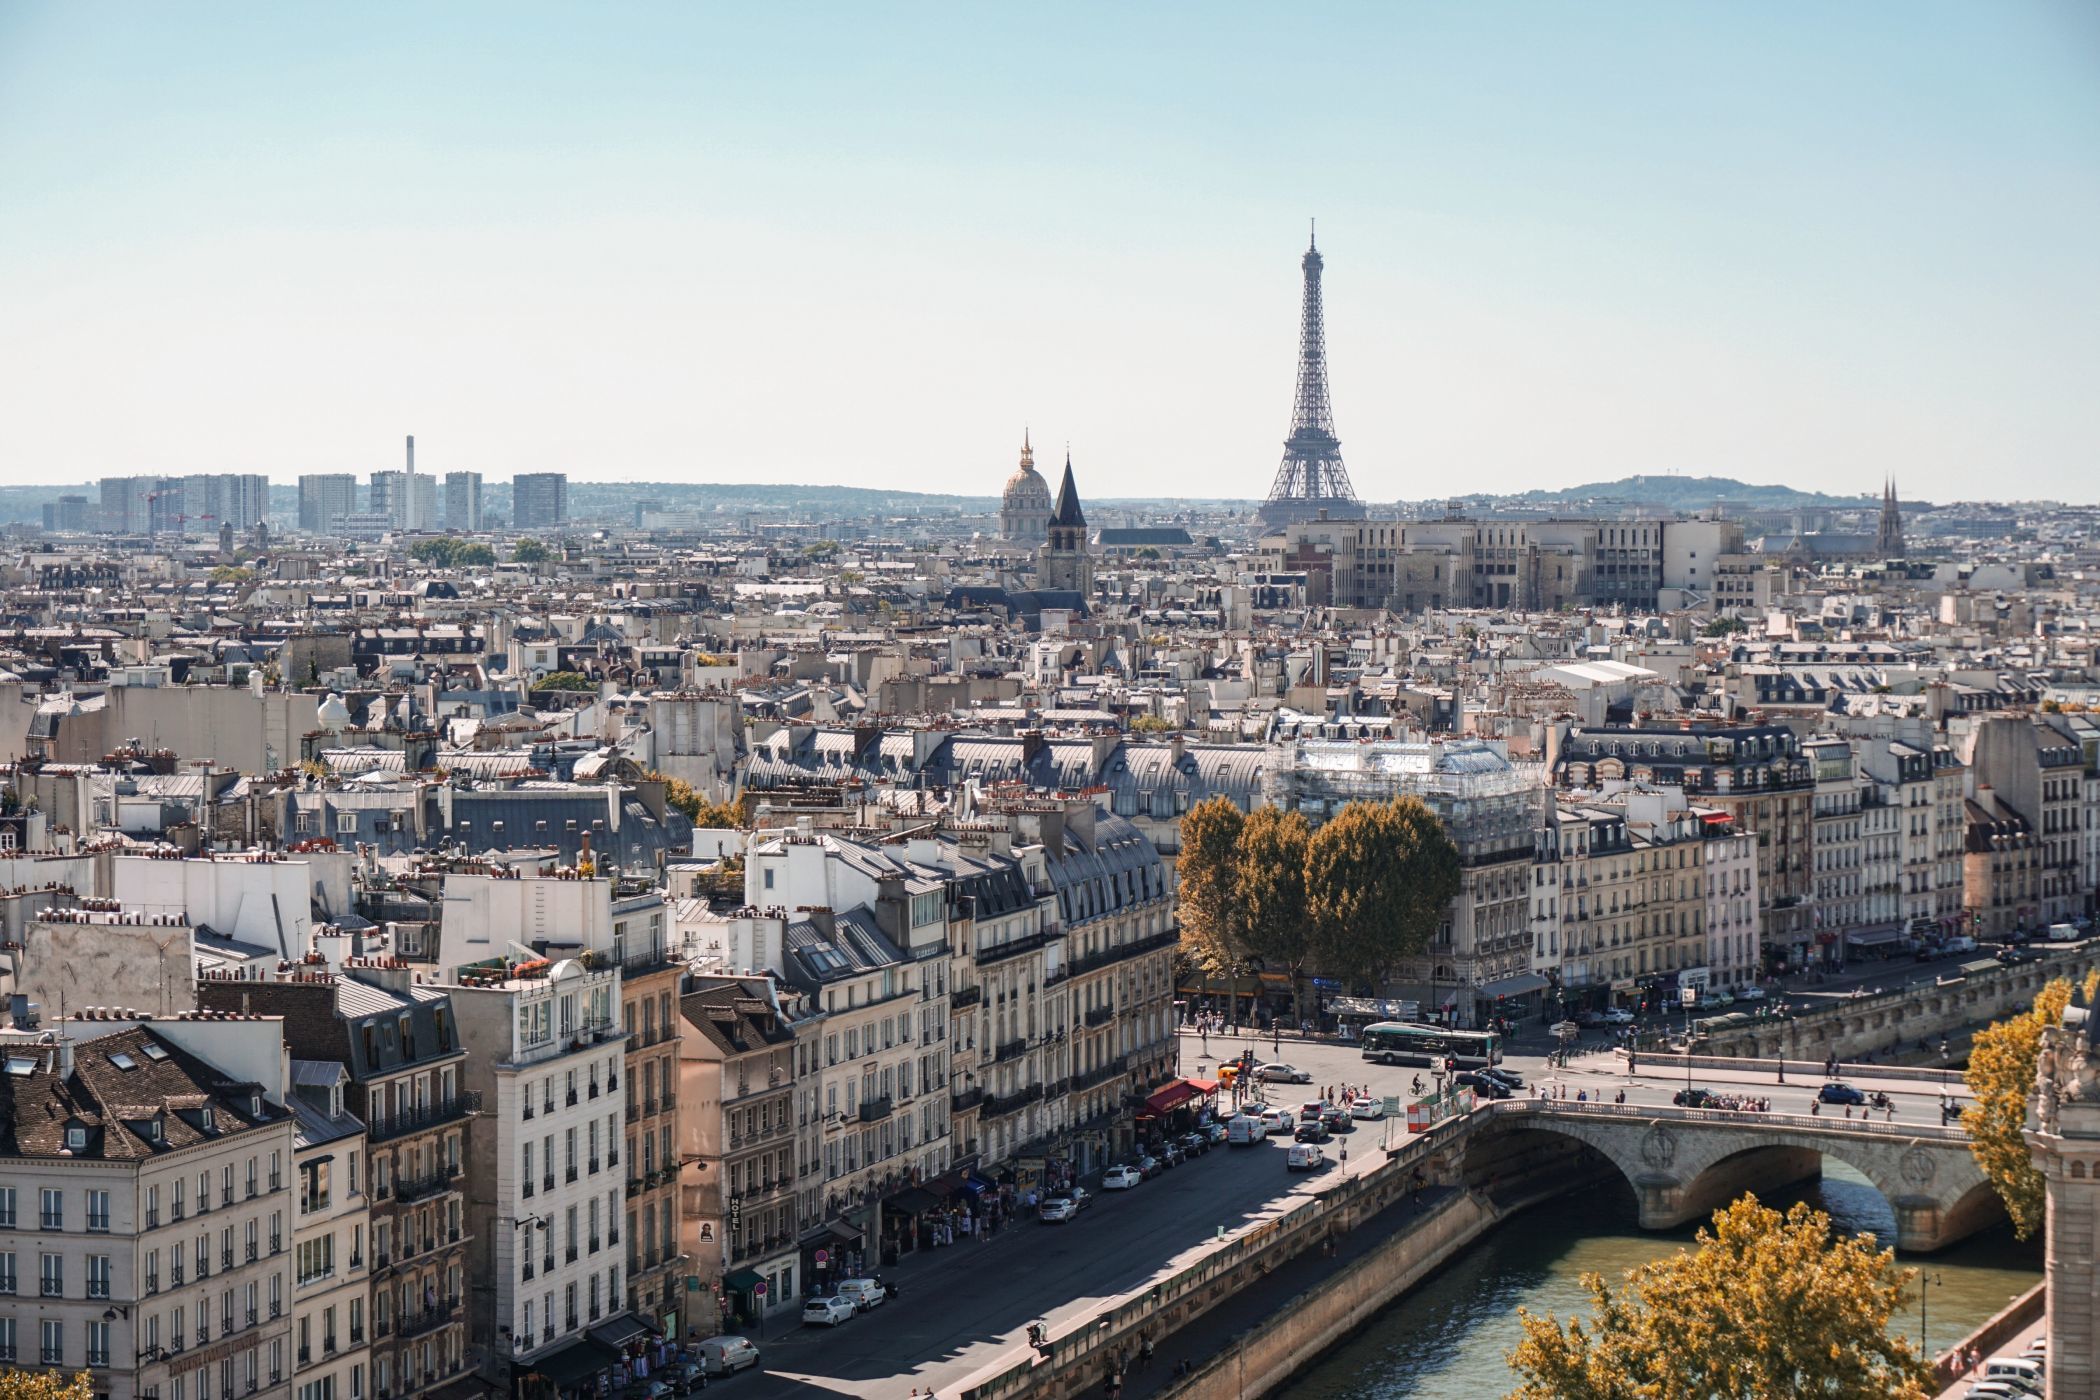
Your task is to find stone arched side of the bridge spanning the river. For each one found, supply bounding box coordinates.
[1464,1100,2003,1253]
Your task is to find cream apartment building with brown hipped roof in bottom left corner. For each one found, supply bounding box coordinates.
[0,1012,294,1400]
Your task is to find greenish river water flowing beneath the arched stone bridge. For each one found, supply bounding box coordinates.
[1281,1159,2041,1400]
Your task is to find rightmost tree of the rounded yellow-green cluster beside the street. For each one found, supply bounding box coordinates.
[1306,798,1460,987]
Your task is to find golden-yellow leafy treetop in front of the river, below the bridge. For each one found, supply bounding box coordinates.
[1510,1196,1932,1400]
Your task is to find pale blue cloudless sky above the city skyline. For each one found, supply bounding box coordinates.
[0,0,2100,500]
